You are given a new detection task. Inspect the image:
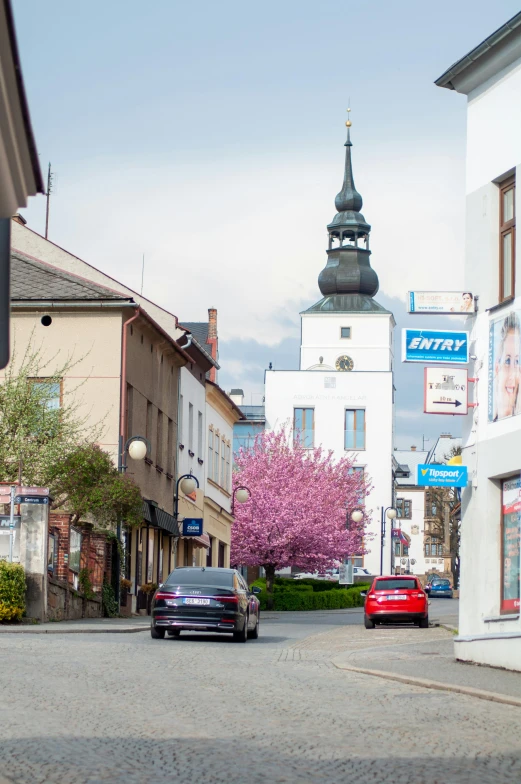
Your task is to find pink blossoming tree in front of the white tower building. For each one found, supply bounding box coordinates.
[231,430,370,604]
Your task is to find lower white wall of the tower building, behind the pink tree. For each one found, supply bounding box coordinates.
[265,370,393,574]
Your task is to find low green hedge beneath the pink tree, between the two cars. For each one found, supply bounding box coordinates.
[253,578,369,611]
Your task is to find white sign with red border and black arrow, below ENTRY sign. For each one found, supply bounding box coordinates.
[423,367,469,416]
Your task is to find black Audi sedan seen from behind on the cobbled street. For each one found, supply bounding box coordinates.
[150,566,260,642]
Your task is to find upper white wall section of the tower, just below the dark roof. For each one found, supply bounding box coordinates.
[300,313,393,370]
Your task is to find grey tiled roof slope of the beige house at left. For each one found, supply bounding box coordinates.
[11,252,131,302]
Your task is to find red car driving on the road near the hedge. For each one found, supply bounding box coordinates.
[361,575,429,629]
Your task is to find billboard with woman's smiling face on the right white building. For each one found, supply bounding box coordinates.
[488,310,521,422]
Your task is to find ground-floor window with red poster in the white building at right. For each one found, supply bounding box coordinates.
[500,476,521,615]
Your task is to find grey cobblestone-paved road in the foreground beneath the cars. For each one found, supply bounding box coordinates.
[0,611,521,784]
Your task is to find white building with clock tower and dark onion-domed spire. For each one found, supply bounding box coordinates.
[265,120,395,574]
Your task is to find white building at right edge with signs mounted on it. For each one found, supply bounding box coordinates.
[436,13,521,670]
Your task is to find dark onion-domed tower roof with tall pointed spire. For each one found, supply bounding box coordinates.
[307,109,388,313]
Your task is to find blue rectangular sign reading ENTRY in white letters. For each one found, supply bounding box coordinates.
[402,329,469,365]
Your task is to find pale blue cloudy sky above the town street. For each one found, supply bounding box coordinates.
[13,0,519,448]
